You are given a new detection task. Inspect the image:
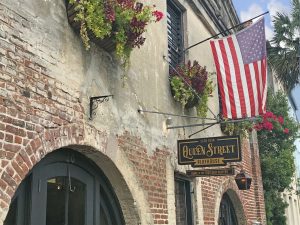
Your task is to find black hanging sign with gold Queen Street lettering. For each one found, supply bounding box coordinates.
[177,136,242,167]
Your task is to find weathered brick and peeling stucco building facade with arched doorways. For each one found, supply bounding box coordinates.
[0,0,266,225]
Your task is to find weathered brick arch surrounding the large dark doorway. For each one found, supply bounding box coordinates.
[0,124,151,225]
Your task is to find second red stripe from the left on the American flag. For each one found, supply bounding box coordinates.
[219,39,236,118]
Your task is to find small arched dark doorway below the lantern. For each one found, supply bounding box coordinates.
[218,193,238,225]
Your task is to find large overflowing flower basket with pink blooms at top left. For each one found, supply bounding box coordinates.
[67,0,163,64]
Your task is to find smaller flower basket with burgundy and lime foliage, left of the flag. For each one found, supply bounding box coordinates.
[170,60,213,117]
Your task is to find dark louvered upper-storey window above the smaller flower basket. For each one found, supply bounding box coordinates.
[167,0,183,68]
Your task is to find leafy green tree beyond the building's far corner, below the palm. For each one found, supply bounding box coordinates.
[257,92,299,225]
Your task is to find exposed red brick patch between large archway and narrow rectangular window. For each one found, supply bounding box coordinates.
[119,132,169,224]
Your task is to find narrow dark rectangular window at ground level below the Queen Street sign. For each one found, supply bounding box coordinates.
[175,177,193,225]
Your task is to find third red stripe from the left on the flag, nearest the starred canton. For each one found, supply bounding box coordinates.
[228,37,247,118]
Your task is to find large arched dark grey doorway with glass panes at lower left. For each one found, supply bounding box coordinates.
[4,150,125,225]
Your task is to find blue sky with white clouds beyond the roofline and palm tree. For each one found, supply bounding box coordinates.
[232,0,300,177]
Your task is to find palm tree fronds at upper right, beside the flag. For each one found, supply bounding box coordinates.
[268,0,300,93]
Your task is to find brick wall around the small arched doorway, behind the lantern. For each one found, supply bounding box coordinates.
[201,139,266,225]
